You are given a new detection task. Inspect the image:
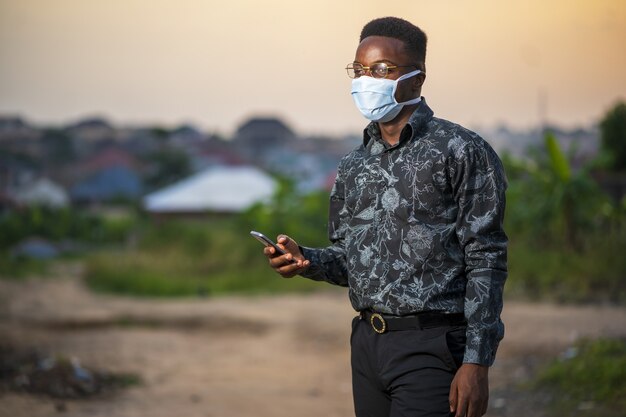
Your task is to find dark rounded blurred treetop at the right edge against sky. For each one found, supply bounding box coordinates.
[600,101,626,172]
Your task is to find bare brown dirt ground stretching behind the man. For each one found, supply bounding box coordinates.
[0,269,626,417]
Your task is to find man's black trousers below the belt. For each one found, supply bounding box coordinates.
[350,317,466,417]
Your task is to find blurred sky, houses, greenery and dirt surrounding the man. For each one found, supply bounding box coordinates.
[0,0,626,416]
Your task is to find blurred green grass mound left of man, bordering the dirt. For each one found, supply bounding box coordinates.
[85,221,328,297]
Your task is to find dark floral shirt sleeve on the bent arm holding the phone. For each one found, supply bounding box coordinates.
[300,167,349,287]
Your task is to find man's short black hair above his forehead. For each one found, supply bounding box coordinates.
[359,17,427,71]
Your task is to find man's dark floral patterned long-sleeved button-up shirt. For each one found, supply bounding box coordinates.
[302,100,507,365]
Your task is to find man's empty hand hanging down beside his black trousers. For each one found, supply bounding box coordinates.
[450,363,489,417]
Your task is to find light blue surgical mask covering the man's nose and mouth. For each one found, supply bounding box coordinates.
[352,70,422,122]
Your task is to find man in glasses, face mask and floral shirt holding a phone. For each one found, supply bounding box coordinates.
[264,17,507,417]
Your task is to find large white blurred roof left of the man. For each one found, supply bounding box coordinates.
[144,167,277,213]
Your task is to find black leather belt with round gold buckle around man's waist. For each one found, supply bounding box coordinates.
[359,310,467,333]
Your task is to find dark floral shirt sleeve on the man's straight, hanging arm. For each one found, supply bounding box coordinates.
[451,138,507,366]
